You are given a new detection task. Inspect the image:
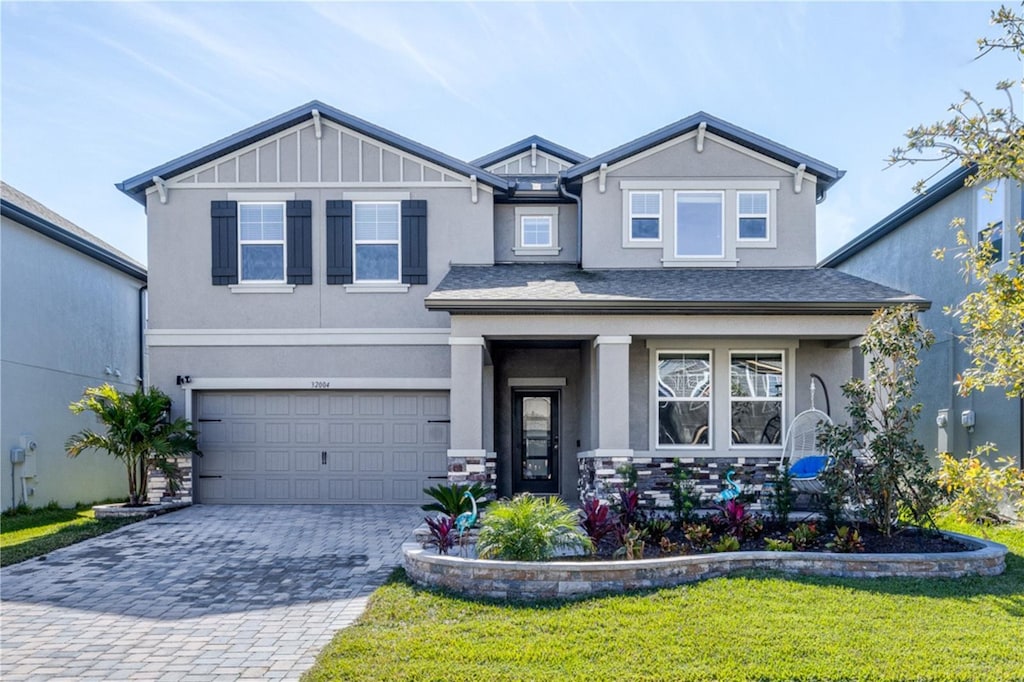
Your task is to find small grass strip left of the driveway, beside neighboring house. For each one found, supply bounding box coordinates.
[0,497,138,566]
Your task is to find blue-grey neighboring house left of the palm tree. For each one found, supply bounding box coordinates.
[0,183,145,508]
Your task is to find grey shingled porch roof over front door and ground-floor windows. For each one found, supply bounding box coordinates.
[425,264,930,315]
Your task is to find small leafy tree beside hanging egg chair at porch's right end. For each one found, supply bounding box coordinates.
[822,305,934,535]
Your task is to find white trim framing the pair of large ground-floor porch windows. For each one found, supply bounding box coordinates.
[637,337,800,458]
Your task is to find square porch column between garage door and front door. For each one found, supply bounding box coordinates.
[449,336,484,457]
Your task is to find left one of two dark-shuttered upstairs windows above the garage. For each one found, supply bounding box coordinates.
[239,202,285,282]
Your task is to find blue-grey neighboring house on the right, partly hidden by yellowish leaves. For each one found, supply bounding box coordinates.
[820,168,1024,466]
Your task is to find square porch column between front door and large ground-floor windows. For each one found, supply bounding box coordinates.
[594,336,633,457]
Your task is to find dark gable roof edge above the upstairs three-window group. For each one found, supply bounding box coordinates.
[565,112,846,194]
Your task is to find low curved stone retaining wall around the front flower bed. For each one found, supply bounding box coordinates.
[402,532,1007,601]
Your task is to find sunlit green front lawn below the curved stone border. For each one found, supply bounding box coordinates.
[303,522,1024,682]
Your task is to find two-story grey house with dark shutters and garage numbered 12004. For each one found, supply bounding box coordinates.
[118,101,927,504]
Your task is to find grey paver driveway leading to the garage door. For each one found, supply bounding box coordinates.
[0,505,423,682]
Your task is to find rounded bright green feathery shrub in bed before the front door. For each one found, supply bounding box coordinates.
[476,493,591,561]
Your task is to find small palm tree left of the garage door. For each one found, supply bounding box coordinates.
[65,384,198,507]
